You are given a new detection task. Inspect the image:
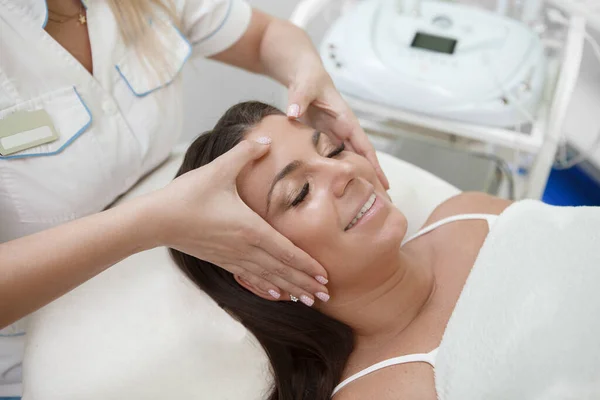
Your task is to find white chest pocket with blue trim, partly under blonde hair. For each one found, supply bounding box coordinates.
[115,22,192,97]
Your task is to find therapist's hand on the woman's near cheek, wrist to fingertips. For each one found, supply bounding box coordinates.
[153,138,328,305]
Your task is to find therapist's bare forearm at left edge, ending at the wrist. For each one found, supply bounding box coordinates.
[0,195,153,328]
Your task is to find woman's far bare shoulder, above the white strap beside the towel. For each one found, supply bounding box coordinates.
[426,192,512,225]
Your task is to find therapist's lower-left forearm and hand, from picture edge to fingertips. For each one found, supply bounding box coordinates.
[0,141,328,329]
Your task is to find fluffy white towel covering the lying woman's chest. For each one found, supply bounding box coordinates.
[435,201,600,400]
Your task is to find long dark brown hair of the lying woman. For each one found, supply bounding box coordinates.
[170,102,354,400]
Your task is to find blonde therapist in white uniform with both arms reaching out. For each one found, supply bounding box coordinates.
[0,0,385,397]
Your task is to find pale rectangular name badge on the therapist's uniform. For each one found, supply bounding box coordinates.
[0,110,58,156]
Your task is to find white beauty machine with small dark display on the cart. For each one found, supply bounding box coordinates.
[320,0,546,127]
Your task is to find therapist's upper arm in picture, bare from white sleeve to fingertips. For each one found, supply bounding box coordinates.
[211,10,389,189]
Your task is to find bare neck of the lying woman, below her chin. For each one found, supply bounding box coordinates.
[328,244,436,347]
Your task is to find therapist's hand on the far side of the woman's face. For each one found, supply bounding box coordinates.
[287,72,390,189]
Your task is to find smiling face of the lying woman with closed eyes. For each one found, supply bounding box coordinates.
[237,116,407,294]
